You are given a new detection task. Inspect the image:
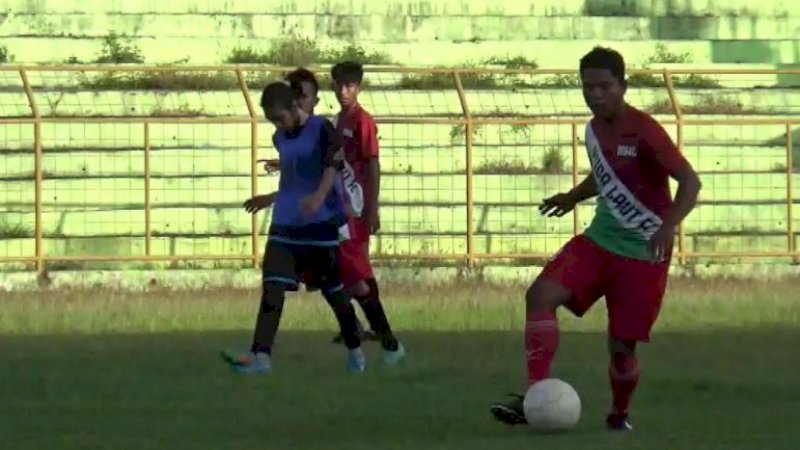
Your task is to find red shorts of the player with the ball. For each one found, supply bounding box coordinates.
[539,235,670,342]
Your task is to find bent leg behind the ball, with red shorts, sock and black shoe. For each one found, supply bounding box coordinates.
[491,236,603,425]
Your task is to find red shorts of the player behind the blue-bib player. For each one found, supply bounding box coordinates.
[300,218,375,291]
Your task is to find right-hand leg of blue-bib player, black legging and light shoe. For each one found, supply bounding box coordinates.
[304,247,366,372]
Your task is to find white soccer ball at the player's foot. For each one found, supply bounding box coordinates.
[522,378,581,432]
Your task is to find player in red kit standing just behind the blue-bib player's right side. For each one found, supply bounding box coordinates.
[331,61,405,363]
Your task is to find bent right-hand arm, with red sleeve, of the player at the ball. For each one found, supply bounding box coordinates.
[646,121,702,228]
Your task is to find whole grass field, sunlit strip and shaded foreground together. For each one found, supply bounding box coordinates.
[0,280,800,450]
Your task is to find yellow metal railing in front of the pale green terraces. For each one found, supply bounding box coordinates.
[0,65,800,272]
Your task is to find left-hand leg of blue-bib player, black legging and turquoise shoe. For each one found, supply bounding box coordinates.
[222,241,297,373]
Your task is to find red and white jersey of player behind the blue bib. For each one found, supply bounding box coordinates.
[336,104,378,216]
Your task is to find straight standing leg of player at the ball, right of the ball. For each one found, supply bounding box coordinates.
[606,257,669,430]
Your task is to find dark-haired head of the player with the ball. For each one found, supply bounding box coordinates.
[580,47,627,119]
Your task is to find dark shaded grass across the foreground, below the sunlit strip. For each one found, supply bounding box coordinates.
[0,328,800,450]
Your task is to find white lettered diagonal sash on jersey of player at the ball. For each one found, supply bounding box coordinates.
[586,124,661,240]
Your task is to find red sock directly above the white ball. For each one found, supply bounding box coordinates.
[525,311,558,384]
